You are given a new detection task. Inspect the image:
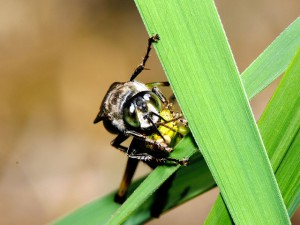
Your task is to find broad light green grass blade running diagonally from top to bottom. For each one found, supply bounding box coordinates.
[131,0,289,224]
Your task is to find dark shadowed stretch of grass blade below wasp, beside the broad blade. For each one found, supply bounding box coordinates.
[124,150,216,225]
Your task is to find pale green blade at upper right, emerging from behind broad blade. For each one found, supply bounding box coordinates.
[242,17,300,99]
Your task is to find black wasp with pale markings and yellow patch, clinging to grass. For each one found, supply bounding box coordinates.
[94,34,188,203]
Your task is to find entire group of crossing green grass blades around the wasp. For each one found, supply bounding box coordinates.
[48,0,300,224]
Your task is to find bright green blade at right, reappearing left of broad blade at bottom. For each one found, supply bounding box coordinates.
[205,48,300,224]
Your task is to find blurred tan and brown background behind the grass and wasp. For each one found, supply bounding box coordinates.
[0,0,300,225]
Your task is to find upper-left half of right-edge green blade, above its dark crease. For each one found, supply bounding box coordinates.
[258,48,300,172]
